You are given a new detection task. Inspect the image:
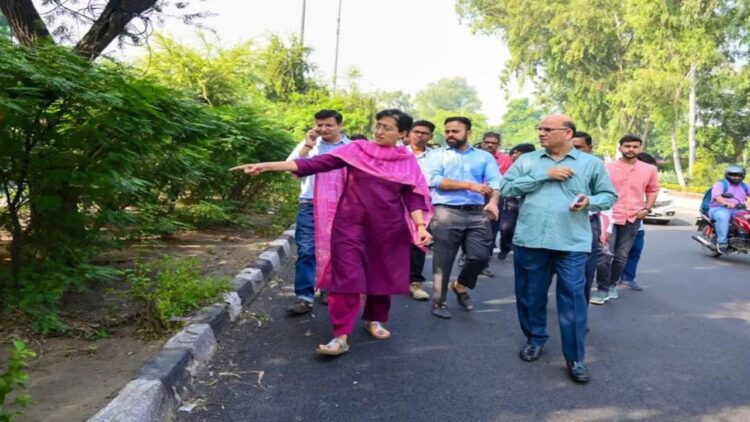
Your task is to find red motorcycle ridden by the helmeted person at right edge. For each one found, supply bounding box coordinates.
[692,192,750,257]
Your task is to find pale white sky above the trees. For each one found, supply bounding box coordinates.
[123,0,528,124]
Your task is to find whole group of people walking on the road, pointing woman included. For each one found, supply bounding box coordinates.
[232,109,659,383]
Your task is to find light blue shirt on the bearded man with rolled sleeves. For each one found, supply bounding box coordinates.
[427,147,503,205]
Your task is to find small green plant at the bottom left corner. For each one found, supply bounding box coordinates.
[0,340,36,422]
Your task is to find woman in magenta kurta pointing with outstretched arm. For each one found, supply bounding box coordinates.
[233,110,431,355]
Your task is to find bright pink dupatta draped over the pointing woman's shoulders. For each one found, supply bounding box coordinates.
[313,141,432,287]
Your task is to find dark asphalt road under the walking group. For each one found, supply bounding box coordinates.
[179,211,750,421]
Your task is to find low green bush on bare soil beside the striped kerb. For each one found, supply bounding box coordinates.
[123,256,229,338]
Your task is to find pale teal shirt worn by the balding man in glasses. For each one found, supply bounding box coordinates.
[500,148,617,252]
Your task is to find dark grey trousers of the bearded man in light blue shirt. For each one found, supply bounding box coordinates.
[430,205,492,303]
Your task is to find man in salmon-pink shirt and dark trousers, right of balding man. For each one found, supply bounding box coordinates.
[591,135,659,305]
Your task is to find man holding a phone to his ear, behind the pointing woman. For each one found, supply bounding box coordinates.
[286,110,350,316]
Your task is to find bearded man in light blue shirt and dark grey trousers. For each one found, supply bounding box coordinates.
[428,117,502,319]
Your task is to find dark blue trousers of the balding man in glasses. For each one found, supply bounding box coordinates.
[513,245,588,361]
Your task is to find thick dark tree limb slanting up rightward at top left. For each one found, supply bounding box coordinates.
[74,0,158,60]
